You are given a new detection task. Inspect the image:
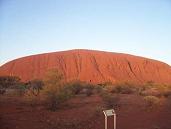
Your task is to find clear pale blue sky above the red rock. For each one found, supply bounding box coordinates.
[0,0,171,65]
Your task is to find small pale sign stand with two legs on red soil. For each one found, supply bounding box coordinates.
[103,109,116,129]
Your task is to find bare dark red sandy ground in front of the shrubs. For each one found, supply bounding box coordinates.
[0,95,171,129]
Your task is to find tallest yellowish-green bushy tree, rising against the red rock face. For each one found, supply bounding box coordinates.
[43,69,70,111]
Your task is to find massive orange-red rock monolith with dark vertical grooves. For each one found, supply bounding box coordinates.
[0,50,171,84]
